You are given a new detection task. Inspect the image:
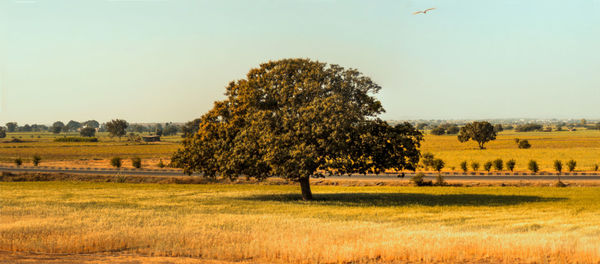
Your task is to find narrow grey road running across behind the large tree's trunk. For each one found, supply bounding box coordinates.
[0,166,600,181]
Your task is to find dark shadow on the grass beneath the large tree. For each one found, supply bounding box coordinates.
[239,193,566,207]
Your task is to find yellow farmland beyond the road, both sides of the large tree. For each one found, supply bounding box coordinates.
[0,130,600,171]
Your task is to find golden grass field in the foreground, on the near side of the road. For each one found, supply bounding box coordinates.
[0,182,600,263]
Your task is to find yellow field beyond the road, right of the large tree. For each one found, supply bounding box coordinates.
[421,130,600,171]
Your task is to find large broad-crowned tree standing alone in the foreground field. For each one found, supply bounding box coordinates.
[172,59,423,200]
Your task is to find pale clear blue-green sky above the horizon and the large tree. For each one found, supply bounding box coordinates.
[0,0,600,124]
